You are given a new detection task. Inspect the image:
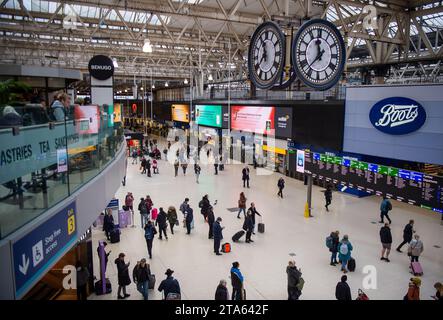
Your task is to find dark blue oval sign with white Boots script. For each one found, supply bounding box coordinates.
[369,97,426,135]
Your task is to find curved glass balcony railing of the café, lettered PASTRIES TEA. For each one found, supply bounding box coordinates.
[0,106,124,239]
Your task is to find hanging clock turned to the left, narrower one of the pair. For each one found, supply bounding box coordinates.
[248,21,286,89]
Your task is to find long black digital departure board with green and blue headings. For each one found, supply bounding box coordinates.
[305,151,443,213]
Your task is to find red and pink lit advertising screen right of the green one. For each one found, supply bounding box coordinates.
[231,106,275,134]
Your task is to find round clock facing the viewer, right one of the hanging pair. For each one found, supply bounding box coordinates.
[292,19,346,90]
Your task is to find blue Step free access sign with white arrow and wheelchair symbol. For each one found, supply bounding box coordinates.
[12,202,77,299]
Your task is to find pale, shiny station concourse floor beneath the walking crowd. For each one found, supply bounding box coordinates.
[89,151,443,300]
